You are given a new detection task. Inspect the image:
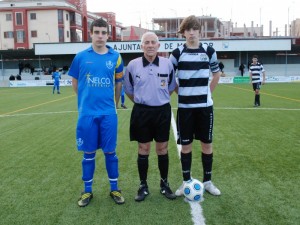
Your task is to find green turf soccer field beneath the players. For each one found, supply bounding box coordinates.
[0,83,300,225]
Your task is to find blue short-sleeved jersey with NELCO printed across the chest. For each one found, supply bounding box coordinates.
[69,46,123,115]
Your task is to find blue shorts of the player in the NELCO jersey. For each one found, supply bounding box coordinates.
[76,114,118,152]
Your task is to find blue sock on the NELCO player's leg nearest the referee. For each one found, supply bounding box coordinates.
[104,152,119,191]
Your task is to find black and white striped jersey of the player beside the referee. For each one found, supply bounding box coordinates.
[170,44,220,108]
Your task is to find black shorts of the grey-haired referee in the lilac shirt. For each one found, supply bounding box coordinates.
[130,103,171,143]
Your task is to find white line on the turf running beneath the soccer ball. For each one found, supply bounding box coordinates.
[171,112,205,225]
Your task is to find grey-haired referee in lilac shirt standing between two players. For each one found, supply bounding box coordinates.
[124,32,177,202]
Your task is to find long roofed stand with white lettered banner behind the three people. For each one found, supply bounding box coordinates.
[0,37,300,75]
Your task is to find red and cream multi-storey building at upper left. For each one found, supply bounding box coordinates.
[0,0,124,50]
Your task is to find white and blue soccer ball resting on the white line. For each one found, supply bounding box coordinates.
[183,179,204,202]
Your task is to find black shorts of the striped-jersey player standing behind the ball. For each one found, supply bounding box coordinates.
[177,106,214,145]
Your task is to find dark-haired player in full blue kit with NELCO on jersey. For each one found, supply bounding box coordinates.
[69,19,125,207]
